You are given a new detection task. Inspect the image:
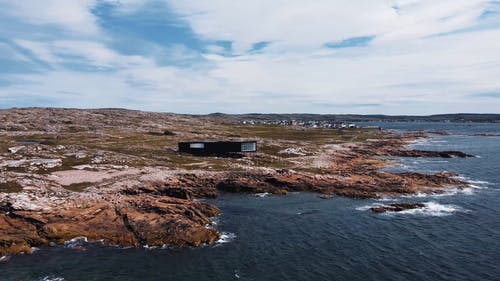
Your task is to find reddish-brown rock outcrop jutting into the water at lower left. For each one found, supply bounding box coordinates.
[0,195,220,255]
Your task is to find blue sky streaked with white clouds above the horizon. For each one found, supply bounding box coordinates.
[0,0,500,115]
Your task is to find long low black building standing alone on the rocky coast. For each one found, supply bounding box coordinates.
[179,141,257,155]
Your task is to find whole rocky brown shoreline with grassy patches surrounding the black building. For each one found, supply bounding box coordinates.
[0,109,472,256]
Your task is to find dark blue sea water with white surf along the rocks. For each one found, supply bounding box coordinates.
[0,123,500,281]
